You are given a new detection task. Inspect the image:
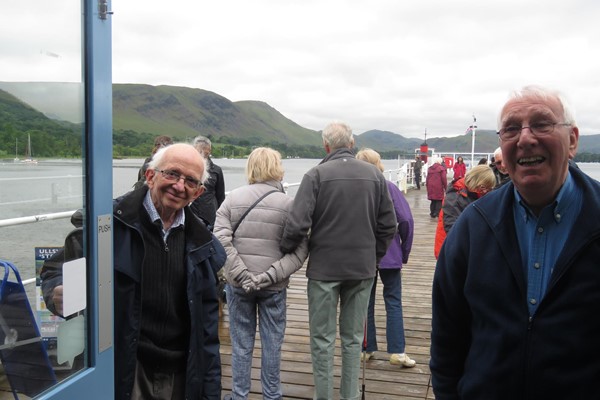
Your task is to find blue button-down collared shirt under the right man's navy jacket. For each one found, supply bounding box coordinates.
[513,173,583,316]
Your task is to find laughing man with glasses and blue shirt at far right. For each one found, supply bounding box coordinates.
[430,86,600,400]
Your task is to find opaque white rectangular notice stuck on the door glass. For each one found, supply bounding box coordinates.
[63,258,87,317]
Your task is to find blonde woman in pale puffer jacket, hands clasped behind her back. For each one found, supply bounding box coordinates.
[214,147,308,399]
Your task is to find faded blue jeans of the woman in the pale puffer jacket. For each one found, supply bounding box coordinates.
[225,285,286,400]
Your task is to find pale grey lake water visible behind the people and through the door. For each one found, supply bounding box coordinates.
[0,159,600,279]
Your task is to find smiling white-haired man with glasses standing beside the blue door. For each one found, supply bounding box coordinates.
[114,143,226,400]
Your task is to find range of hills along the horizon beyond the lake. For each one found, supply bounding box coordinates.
[0,82,600,154]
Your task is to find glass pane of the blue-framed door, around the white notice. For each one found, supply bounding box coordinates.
[0,0,87,399]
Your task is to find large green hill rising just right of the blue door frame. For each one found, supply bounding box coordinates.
[113,84,321,145]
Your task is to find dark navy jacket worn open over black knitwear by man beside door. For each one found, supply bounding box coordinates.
[113,186,226,400]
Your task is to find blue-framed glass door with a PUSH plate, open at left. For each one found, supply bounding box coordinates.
[0,0,113,400]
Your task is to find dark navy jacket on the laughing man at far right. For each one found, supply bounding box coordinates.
[430,168,600,400]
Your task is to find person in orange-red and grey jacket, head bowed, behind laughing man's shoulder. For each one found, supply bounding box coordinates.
[433,165,496,259]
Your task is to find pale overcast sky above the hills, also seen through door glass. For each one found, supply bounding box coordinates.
[0,0,600,138]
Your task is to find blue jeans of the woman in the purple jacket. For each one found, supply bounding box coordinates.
[366,269,406,354]
